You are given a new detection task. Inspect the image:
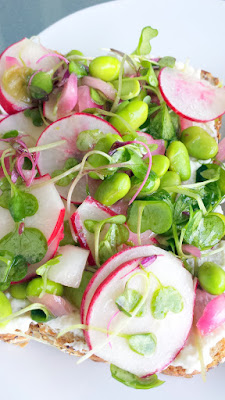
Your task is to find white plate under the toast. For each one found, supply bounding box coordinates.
[0,0,225,400]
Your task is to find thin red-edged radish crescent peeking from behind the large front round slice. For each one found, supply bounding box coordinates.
[80,245,169,324]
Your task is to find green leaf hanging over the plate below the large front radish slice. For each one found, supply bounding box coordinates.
[110,364,164,389]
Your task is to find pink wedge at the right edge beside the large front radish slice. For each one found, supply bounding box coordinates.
[197,294,225,336]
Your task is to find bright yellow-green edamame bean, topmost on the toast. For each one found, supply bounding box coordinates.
[89,56,121,82]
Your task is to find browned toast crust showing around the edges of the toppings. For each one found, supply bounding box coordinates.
[0,70,225,378]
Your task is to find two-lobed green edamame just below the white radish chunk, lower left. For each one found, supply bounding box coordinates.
[26,278,63,297]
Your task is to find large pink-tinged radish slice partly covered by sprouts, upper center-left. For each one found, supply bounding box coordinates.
[37,114,120,204]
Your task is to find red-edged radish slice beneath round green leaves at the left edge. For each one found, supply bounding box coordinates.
[0,176,65,245]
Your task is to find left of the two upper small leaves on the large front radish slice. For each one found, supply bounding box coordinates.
[115,287,144,317]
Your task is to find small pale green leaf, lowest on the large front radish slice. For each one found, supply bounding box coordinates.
[127,333,157,357]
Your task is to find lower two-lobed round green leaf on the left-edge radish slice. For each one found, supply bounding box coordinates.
[0,228,48,264]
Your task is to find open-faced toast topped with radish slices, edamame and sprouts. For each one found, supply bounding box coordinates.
[0,27,225,389]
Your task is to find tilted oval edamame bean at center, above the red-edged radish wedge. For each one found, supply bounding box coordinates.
[95,172,131,206]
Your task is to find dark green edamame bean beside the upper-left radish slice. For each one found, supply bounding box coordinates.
[30,71,53,100]
